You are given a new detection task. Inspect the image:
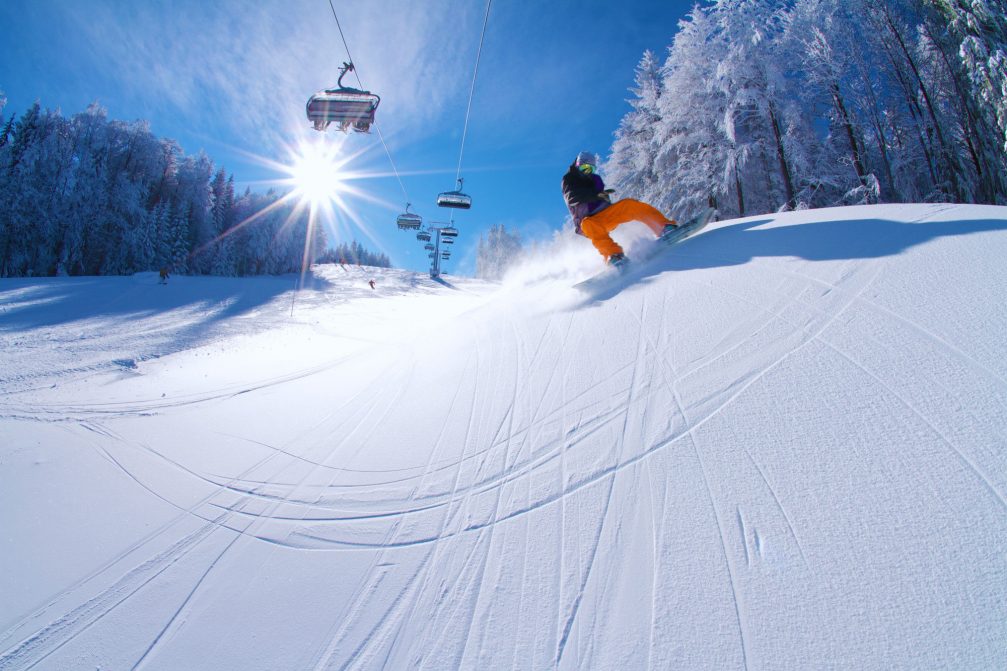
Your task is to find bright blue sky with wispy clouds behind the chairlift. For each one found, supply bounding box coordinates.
[0,0,691,274]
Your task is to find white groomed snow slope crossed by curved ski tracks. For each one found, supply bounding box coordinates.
[0,206,1007,669]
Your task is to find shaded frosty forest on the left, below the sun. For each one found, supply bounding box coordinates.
[0,97,389,277]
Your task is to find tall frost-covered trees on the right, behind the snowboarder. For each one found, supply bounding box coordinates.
[604,0,1007,219]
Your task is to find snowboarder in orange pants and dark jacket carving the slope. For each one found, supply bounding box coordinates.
[563,151,678,267]
